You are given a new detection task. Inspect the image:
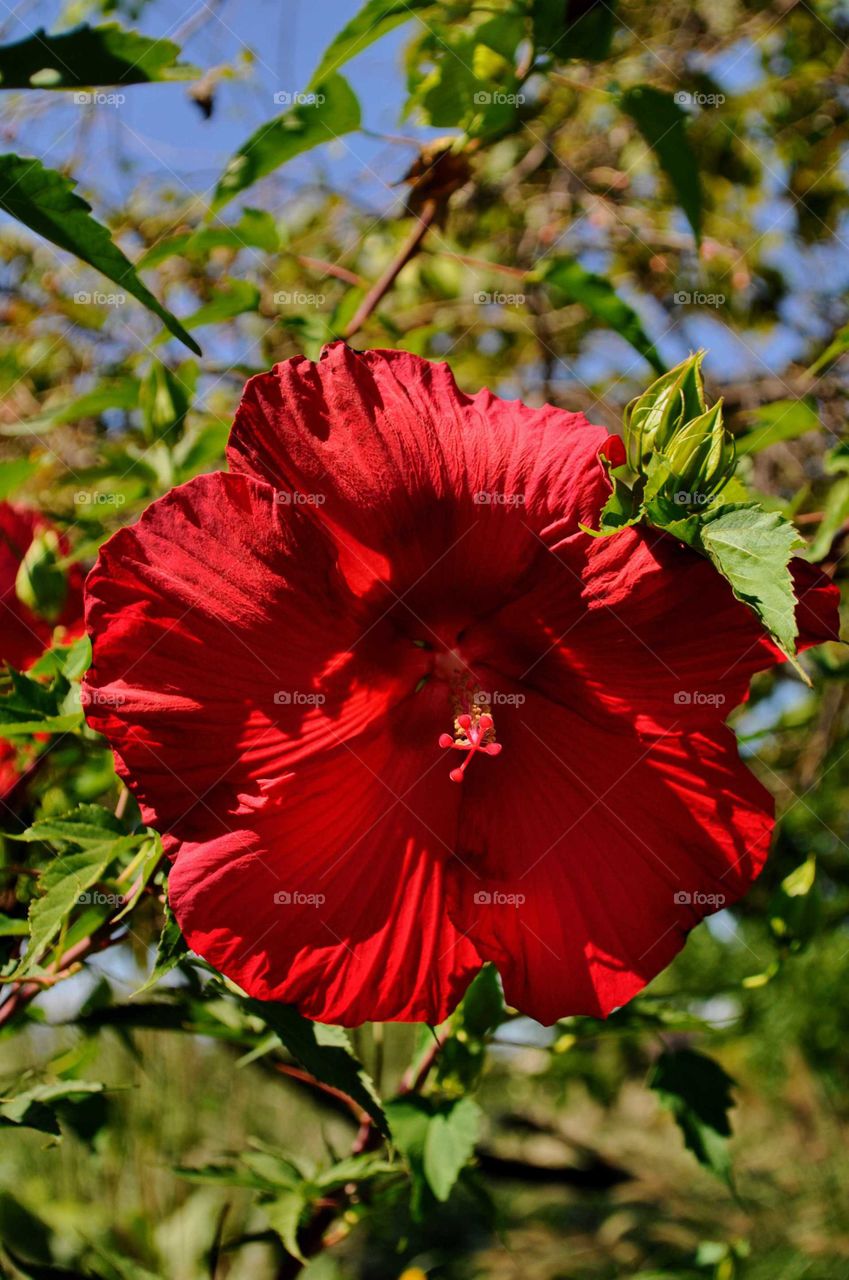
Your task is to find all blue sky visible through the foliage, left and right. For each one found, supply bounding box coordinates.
[0,0,849,380]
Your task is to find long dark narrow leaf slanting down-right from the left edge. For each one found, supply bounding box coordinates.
[0,155,201,356]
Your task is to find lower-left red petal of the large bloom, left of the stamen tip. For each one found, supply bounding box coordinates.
[169,723,481,1025]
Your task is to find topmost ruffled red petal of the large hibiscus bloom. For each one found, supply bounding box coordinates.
[228,343,608,614]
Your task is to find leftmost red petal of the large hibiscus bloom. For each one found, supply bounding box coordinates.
[83,474,417,838]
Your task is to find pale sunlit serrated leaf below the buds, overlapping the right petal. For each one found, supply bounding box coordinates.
[699,504,804,658]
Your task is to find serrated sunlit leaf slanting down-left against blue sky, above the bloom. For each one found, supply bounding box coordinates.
[213,74,360,210]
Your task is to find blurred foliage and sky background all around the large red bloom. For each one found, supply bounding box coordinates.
[0,0,849,1280]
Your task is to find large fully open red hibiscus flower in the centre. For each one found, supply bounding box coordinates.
[85,344,836,1025]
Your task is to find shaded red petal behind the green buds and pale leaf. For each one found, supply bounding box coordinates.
[470,529,839,732]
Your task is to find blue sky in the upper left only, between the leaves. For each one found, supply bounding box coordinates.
[0,0,423,209]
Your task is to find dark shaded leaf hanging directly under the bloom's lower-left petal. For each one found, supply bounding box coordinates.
[243,1000,389,1135]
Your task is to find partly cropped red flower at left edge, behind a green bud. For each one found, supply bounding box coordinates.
[0,502,83,800]
